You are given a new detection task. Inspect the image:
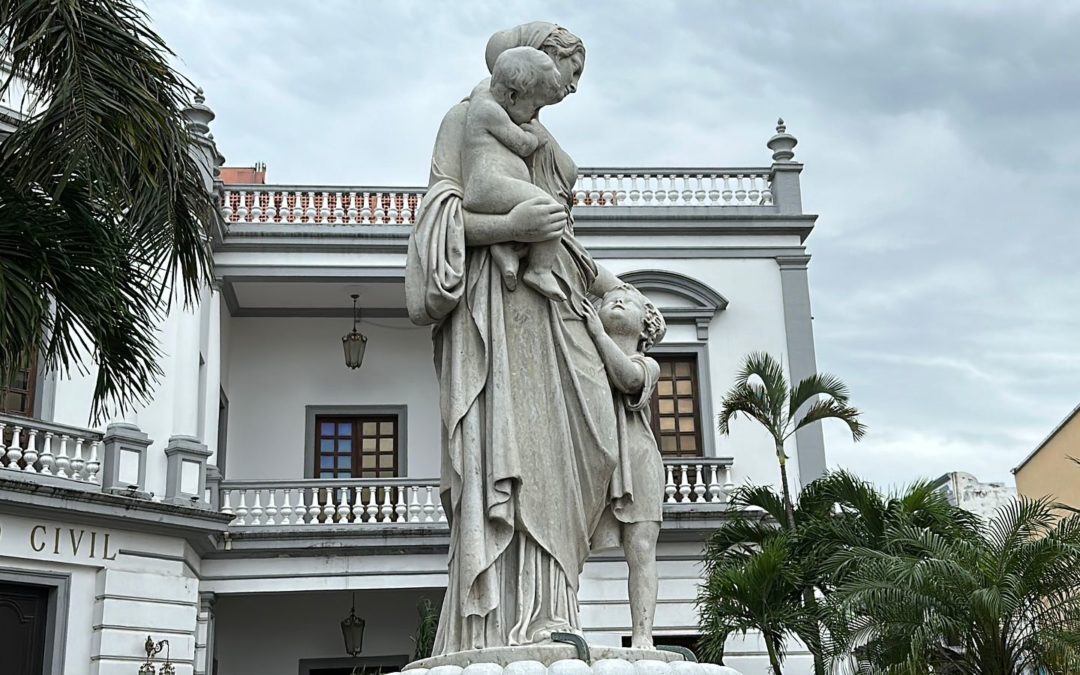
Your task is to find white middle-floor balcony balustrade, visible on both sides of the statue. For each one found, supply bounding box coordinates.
[214,458,731,527]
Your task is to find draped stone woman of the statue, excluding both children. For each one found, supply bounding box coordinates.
[406,22,620,654]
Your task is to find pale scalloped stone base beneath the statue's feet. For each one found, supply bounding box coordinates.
[402,643,739,675]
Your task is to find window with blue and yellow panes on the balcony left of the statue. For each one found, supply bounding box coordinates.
[313,415,399,478]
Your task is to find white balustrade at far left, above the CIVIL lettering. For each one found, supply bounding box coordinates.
[0,415,103,485]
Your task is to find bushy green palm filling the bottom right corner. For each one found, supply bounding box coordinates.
[835,499,1080,675]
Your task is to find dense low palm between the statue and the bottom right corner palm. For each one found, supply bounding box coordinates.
[698,471,978,672]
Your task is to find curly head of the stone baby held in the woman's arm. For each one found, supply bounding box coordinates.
[491,46,564,124]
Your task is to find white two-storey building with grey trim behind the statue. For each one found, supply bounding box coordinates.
[0,95,825,675]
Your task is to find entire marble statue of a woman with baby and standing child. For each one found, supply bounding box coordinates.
[405,22,738,675]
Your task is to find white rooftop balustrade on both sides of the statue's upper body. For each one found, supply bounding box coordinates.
[221,168,772,225]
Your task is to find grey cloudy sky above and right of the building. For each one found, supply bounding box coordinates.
[148,0,1080,485]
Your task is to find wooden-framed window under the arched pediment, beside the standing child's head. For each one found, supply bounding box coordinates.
[650,353,703,458]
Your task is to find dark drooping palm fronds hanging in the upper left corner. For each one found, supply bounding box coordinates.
[0,0,215,421]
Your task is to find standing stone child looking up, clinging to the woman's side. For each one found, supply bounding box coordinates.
[582,284,666,649]
